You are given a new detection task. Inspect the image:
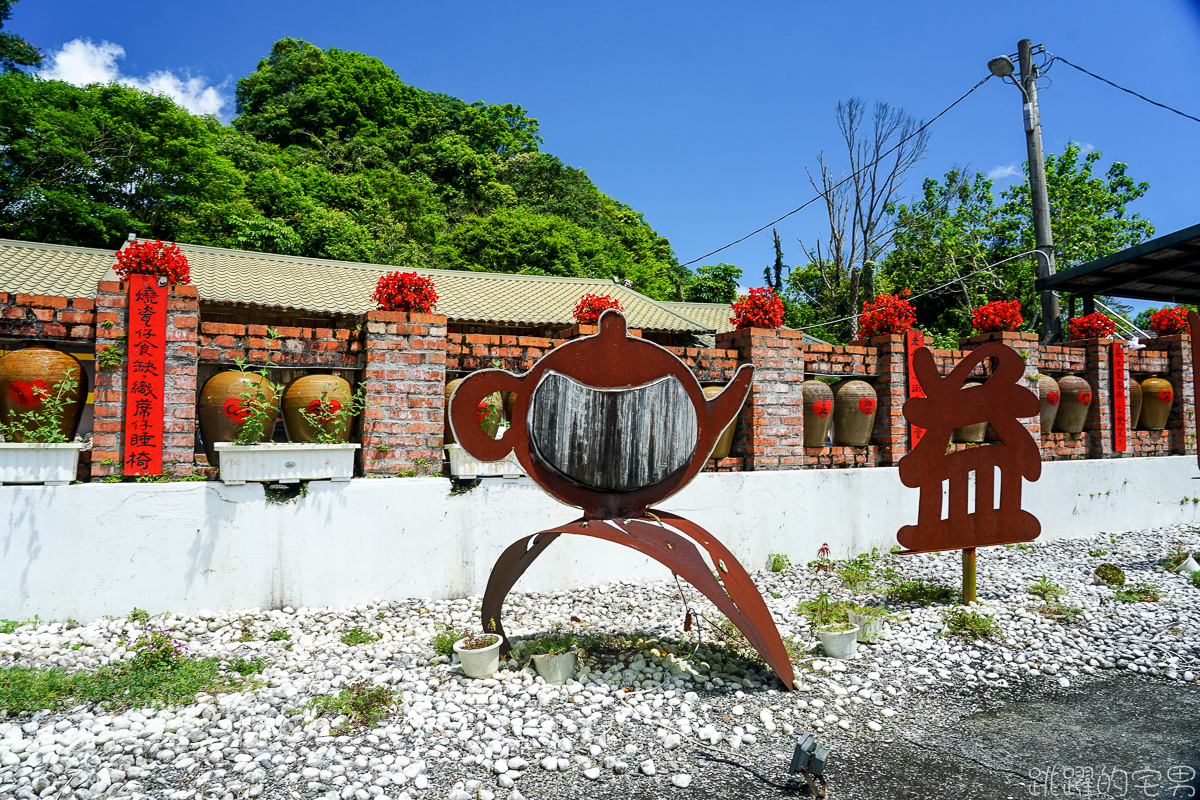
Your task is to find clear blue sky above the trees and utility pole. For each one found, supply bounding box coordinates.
[7,0,1200,303]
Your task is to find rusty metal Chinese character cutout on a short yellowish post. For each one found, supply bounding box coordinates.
[896,342,1042,553]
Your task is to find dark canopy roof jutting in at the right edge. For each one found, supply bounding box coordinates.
[1036,224,1200,311]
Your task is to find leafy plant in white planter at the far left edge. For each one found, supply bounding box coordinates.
[0,367,83,486]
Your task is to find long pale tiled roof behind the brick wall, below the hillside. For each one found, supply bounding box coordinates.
[0,240,714,333]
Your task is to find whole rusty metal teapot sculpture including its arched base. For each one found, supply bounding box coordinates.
[449,309,793,688]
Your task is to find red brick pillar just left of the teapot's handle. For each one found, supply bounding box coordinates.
[362,311,446,475]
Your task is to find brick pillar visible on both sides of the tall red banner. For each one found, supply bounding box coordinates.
[91,281,199,477]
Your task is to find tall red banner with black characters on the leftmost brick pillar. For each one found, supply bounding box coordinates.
[122,275,167,475]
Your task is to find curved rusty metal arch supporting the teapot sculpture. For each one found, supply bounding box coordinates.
[480,511,794,690]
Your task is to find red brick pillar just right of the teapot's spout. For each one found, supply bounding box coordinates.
[716,327,804,470]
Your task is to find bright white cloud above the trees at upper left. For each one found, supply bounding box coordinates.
[40,38,230,116]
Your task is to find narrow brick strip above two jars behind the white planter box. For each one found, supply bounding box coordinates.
[199,323,362,369]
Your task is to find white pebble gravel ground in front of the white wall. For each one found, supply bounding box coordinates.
[0,528,1200,800]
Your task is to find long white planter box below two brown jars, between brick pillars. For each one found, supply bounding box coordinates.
[212,441,362,486]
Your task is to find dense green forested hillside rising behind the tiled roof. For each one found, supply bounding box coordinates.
[0,38,690,300]
